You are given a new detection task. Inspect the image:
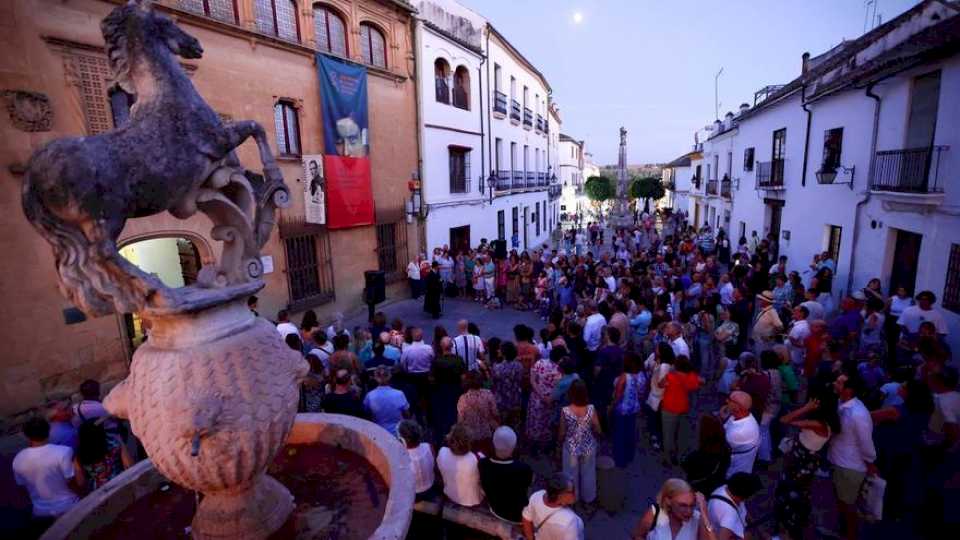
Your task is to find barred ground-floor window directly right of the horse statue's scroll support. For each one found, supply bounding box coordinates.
[279,218,335,311]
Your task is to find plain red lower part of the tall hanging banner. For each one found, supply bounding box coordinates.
[323,155,375,229]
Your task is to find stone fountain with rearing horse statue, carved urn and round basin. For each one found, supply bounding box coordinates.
[23,0,412,539]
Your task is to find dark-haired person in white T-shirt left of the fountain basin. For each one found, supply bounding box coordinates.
[13,418,80,526]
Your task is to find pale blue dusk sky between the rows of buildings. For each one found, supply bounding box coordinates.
[468,0,917,165]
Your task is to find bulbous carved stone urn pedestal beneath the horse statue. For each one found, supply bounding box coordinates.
[104,287,309,539]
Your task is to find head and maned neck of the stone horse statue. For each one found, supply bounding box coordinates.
[100,0,203,93]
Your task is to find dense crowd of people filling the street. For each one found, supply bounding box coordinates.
[14,209,960,540]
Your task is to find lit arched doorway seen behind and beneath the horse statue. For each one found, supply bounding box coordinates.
[120,235,209,358]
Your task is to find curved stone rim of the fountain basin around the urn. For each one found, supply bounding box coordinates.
[41,414,414,540]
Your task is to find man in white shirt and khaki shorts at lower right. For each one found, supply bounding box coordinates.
[827,373,877,540]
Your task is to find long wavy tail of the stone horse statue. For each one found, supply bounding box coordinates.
[22,168,113,316]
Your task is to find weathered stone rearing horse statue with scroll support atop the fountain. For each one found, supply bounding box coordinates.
[23,0,289,316]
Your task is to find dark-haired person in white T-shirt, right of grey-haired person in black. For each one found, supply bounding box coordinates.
[523,472,583,540]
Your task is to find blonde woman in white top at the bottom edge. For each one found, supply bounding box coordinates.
[633,478,716,540]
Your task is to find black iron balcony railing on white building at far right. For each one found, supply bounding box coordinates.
[870,146,948,193]
